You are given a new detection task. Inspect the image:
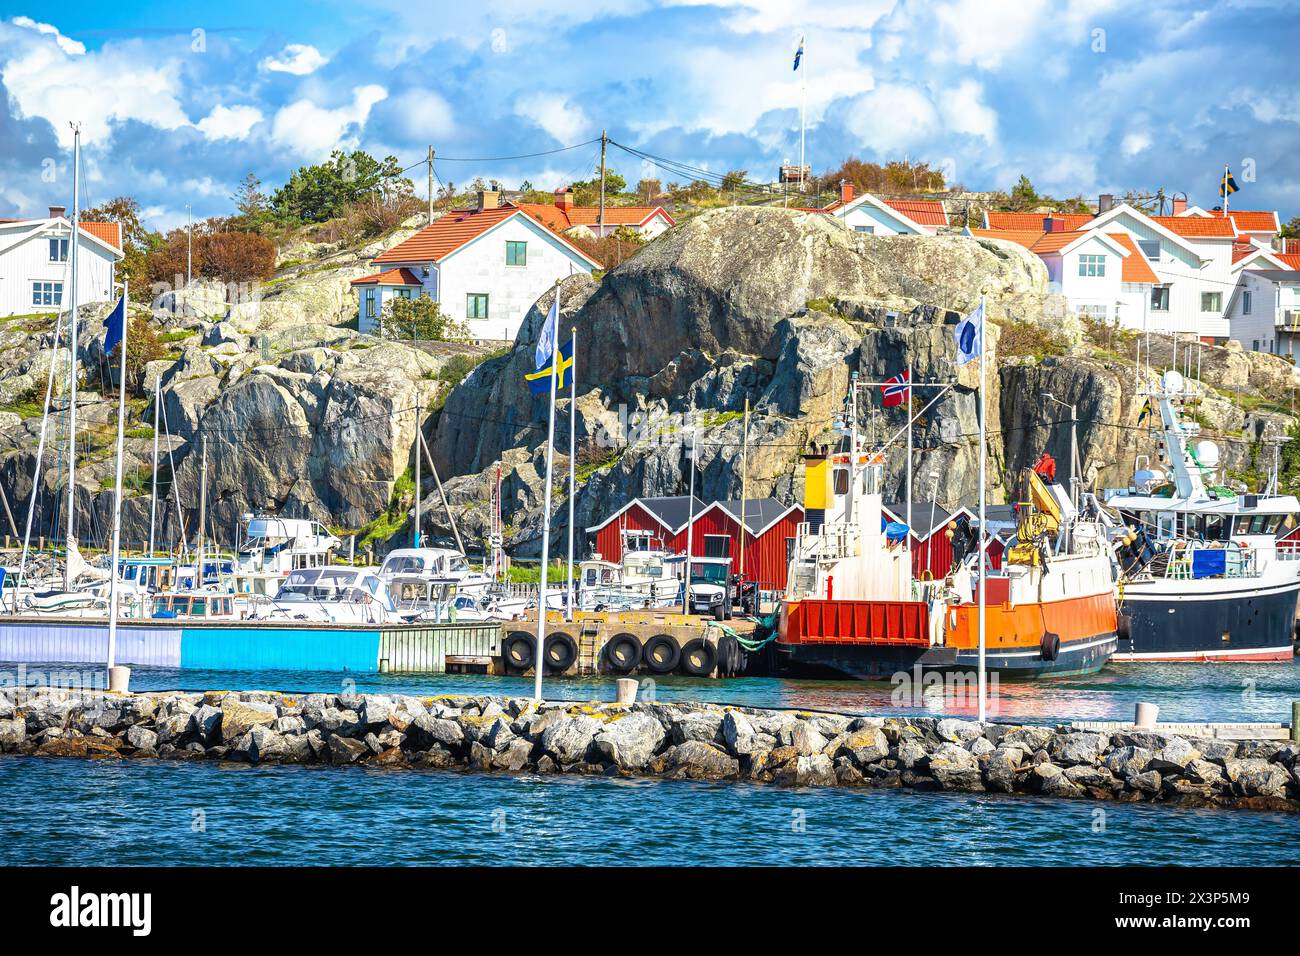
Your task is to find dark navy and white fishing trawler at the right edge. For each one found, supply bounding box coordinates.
[1106,371,1300,661]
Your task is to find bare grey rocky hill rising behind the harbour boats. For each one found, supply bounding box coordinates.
[0,208,1296,555]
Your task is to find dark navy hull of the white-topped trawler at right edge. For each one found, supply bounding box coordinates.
[1114,581,1300,662]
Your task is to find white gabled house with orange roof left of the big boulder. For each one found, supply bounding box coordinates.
[352,193,601,339]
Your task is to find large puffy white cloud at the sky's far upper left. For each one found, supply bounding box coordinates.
[0,18,190,147]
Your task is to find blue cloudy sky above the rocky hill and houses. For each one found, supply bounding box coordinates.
[0,0,1300,228]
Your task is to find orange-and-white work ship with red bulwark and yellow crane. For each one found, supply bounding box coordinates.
[775,442,1117,680]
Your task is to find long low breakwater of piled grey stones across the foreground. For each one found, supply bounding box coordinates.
[0,691,1300,810]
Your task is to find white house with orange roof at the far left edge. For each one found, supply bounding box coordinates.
[0,206,122,316]
